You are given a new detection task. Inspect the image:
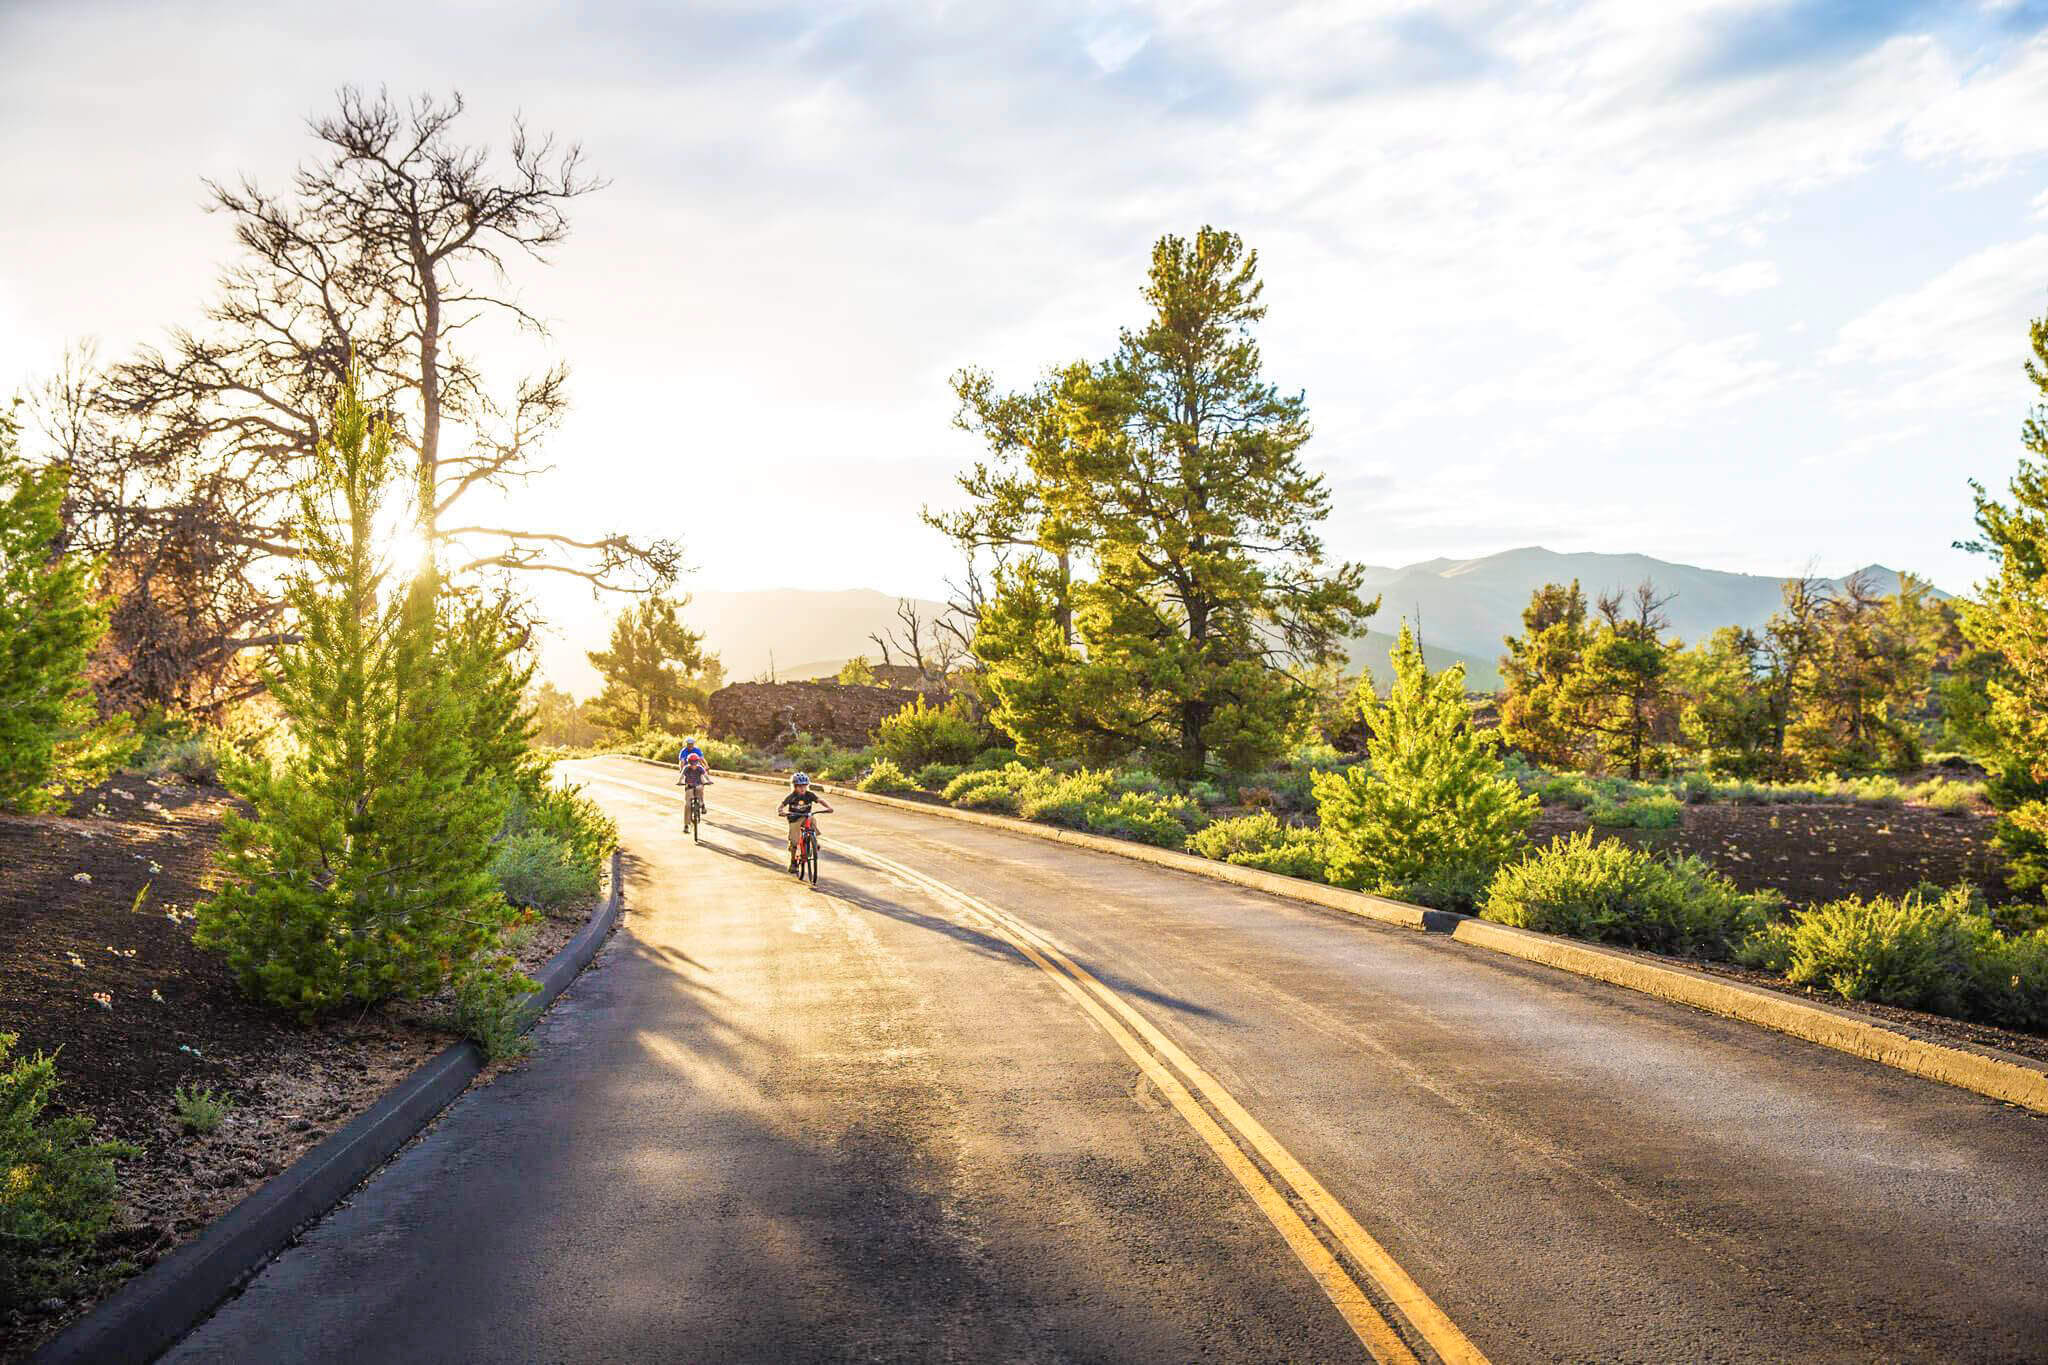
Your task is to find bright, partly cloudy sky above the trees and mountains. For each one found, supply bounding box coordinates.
[0,0,2048,671]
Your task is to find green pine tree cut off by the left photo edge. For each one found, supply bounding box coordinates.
[0,411,119,810]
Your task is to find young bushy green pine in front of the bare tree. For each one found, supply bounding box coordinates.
[197,385,516,1019]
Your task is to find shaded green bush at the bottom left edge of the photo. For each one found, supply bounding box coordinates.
[0,1033,137,1310]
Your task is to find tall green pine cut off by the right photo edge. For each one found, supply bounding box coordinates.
[1962,304,2048,888]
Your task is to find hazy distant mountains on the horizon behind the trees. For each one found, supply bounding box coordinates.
[543,546,1957,696]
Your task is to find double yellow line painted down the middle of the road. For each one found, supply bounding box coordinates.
[577,776,1487,1365]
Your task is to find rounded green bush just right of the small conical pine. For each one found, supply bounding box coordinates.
[1481,831,1780,958]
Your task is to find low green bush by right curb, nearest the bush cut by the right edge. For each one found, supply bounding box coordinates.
[1741,886,2003,1015]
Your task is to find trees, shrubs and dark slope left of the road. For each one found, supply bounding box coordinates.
[0,90,630,1355]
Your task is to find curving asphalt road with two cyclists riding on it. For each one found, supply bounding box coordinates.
[170,759,2048,1365]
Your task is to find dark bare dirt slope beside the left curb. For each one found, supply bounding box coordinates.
[0,776,586,1359]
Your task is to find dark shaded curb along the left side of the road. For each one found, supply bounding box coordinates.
[29,849,621,1365]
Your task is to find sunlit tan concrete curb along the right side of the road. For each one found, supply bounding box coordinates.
[651,755,2048,1113]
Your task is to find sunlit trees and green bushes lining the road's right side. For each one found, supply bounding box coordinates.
[569,272,2048,1055]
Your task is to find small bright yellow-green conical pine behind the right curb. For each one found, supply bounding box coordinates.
[1315,622,1536,911]
